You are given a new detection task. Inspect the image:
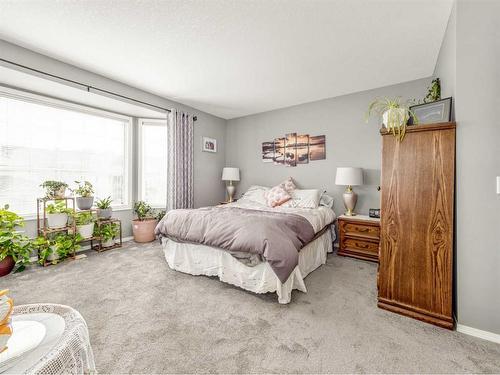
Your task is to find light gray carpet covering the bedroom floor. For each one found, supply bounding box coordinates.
[0,243,500,373]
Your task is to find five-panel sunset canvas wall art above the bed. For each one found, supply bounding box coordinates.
[262,133,326,167]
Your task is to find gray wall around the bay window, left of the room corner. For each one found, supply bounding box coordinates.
[0,39,226,236]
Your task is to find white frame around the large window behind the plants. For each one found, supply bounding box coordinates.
[0,85,133,220]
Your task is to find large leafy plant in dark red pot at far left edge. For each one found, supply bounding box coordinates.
[0,205,32,277]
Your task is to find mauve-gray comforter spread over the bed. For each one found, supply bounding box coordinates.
[155,206,314,283]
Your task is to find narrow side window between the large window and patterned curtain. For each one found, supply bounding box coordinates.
[139,119,168,208]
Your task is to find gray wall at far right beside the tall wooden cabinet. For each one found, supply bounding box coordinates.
[436,0,500,334]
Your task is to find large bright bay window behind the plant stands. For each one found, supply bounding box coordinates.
[0,88,132,216]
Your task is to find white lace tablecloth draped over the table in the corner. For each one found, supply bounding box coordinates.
[6,304,96,374]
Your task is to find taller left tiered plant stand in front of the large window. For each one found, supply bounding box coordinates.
[36,197,76,267]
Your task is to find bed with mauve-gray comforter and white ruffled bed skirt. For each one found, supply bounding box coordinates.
[155,187,335,304]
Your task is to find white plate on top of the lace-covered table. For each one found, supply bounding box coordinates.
[0,320,47,372]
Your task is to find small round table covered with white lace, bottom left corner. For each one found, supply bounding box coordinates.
[0,304,96,374]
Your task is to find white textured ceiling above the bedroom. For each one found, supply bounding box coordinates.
[0,0,452,119]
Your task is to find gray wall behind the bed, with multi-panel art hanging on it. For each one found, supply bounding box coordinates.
[226,78,431,219]
